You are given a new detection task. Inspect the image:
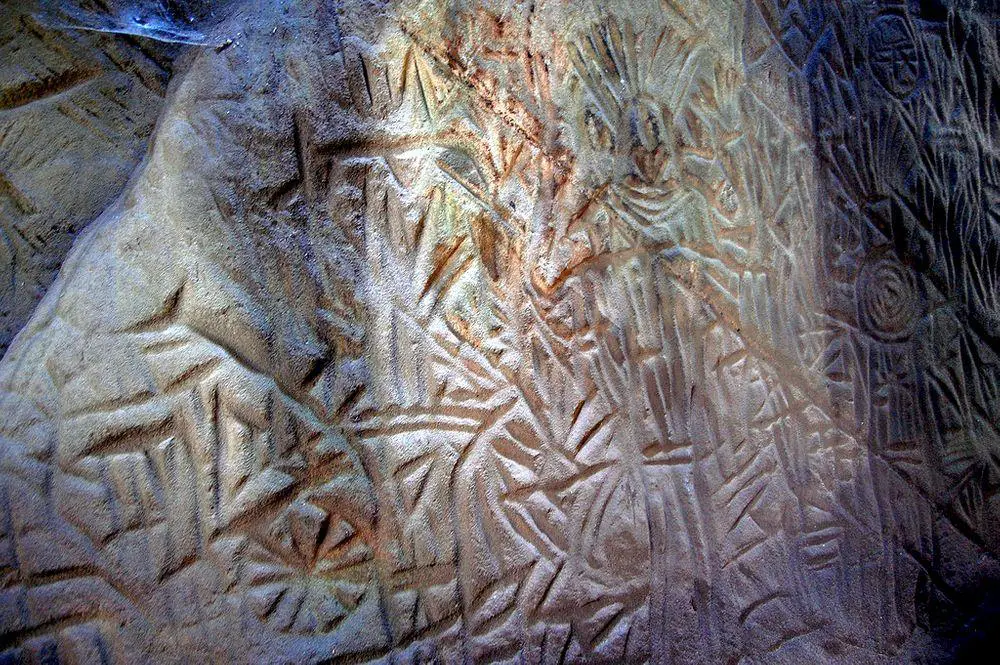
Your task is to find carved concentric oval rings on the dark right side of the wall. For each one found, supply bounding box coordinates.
[855,249,923,342]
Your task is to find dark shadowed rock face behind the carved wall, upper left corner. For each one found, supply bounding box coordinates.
[0,2,177,354]
